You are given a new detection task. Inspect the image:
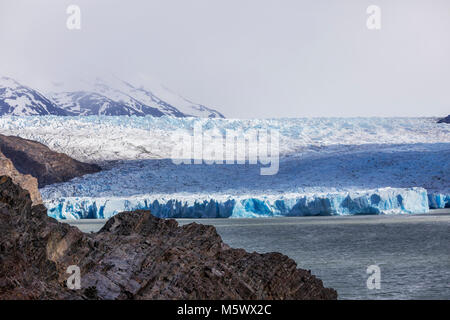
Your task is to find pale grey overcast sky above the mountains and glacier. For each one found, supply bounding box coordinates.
[0,0,450,118]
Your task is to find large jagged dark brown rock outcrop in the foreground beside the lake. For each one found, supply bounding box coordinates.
[0,176,337,299]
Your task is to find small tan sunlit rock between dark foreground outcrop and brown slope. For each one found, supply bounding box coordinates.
[0,151,42,205]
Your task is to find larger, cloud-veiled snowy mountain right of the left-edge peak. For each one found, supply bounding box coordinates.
[49,76,224,118]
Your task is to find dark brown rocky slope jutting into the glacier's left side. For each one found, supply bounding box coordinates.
[0,134,101,188]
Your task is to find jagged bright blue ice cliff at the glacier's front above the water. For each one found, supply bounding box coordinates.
[45,188,429,219]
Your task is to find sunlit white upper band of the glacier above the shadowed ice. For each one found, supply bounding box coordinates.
[0,116,450,163]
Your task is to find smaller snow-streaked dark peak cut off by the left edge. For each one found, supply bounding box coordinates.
[0,77,68,116]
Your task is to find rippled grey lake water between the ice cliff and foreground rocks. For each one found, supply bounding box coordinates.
[69,210,450,299]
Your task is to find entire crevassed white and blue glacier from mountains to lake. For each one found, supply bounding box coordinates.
[0,116,450,218]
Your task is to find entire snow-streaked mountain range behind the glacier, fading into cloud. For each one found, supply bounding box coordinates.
[0,77,224,118]
